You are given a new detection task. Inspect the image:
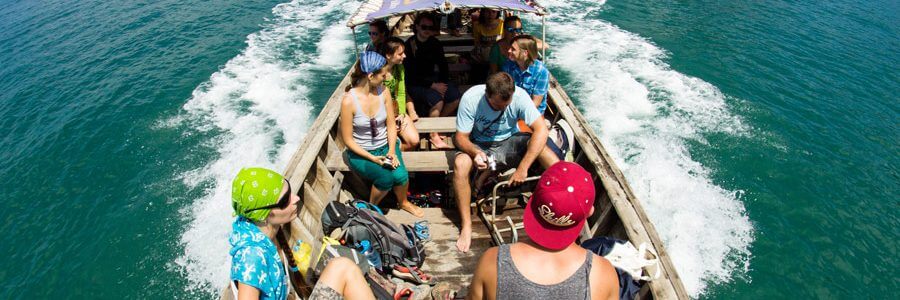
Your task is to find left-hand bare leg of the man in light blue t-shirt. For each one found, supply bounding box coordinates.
[453,154,472,252]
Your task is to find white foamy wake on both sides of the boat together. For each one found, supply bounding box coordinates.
[168,0,753,297]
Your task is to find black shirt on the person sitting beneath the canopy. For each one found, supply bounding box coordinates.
[403,35,450,87]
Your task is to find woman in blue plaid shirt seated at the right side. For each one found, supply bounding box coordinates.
[503,35,550,114]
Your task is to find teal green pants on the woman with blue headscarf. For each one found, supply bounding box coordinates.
[345,141,409,191]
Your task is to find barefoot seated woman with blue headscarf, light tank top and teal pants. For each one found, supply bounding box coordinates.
[339,51,425,217]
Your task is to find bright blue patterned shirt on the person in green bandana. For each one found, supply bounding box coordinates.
[228,217,288,300]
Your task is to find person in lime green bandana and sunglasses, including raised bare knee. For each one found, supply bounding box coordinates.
[228,168,375,300]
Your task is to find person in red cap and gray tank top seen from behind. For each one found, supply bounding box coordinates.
[466,162,619,299]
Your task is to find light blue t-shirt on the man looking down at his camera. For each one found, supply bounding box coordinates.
[456,84,541,143]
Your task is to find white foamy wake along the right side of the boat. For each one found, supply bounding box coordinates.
[542,0,754,297]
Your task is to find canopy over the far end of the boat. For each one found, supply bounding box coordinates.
[347,0,546,28]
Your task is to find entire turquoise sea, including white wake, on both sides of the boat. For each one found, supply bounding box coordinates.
[0,0,900,299]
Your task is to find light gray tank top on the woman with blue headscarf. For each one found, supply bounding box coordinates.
[350,89,387,151]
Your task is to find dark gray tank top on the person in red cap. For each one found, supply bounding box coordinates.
[496,244,593,299]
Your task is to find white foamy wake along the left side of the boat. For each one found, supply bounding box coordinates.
[171,0,354,293]
